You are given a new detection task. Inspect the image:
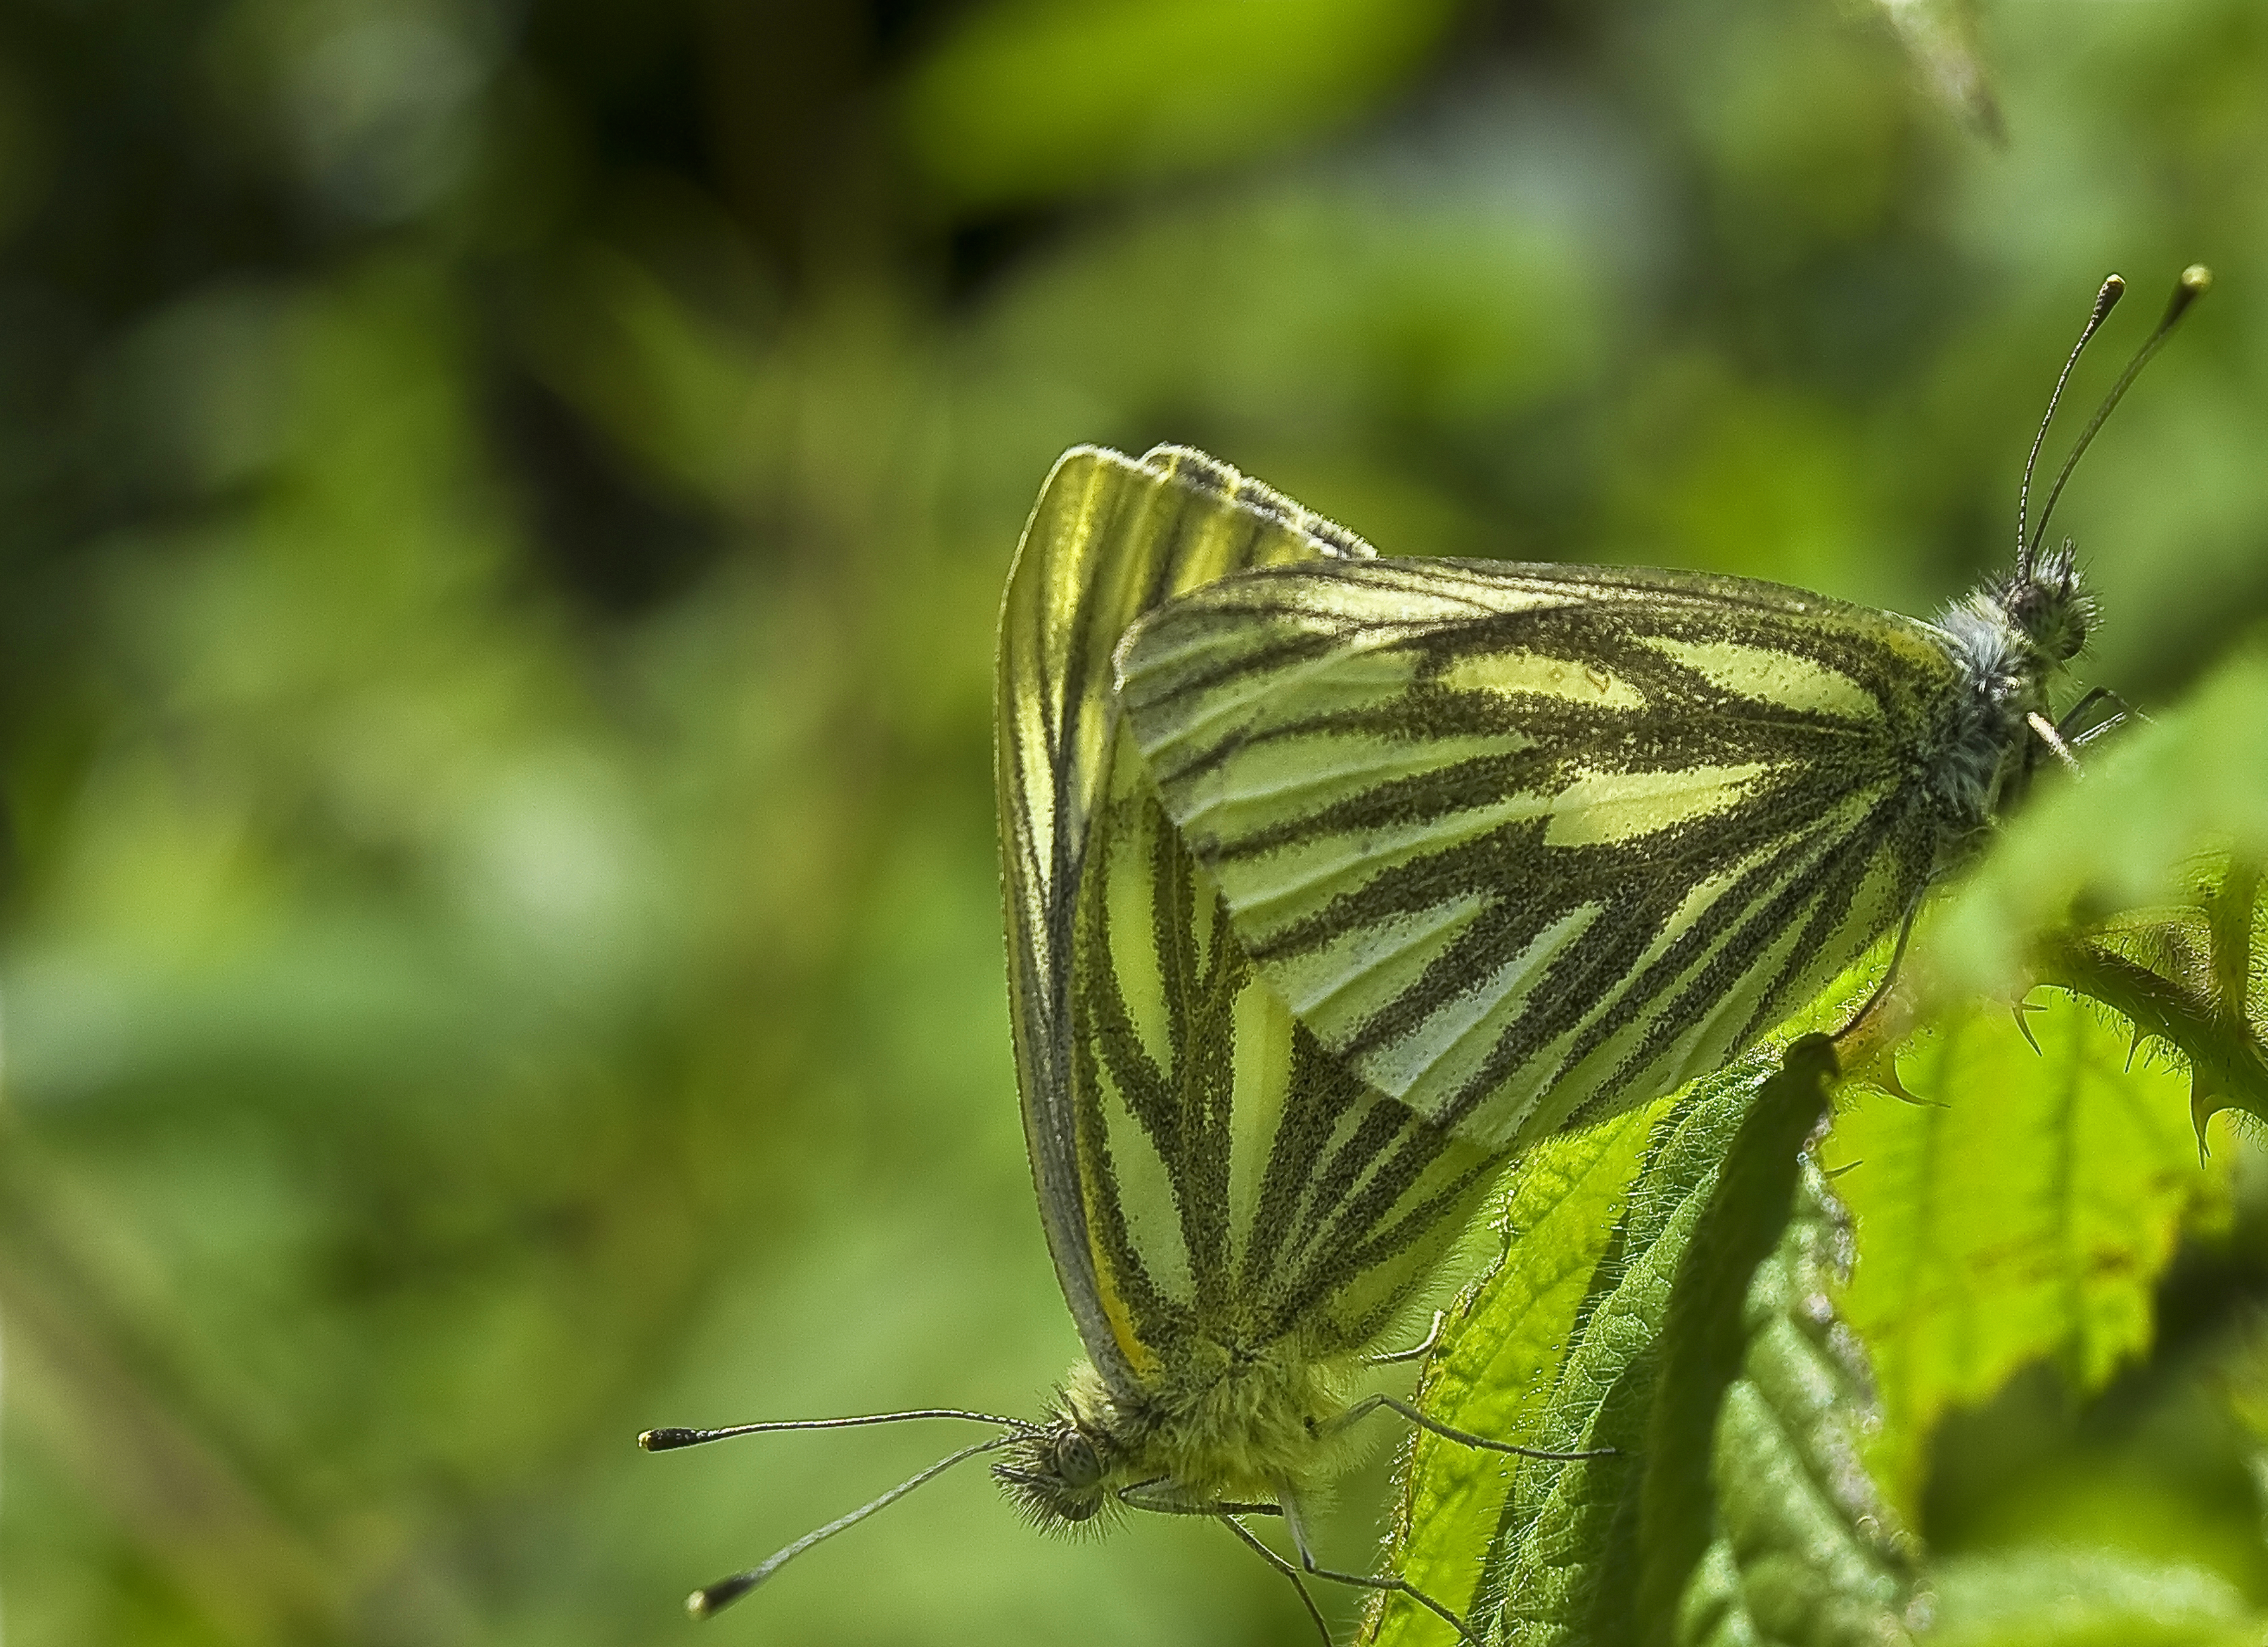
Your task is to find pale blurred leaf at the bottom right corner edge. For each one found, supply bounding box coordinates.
[1930,1547,2268,1647]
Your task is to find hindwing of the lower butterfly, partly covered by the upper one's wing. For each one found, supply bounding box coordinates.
[1064,721,1495,1393]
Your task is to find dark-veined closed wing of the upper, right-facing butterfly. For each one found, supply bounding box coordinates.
[1118,560,1960,1150]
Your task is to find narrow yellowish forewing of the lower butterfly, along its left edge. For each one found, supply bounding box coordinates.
[995,447,1370,1388]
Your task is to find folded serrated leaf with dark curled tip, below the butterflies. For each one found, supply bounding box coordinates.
[1367,1037,1907,1647]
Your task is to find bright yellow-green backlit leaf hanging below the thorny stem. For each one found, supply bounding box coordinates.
[1821,991,2225,1511]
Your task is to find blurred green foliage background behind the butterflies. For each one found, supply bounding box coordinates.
[0,0,2268,1647]
